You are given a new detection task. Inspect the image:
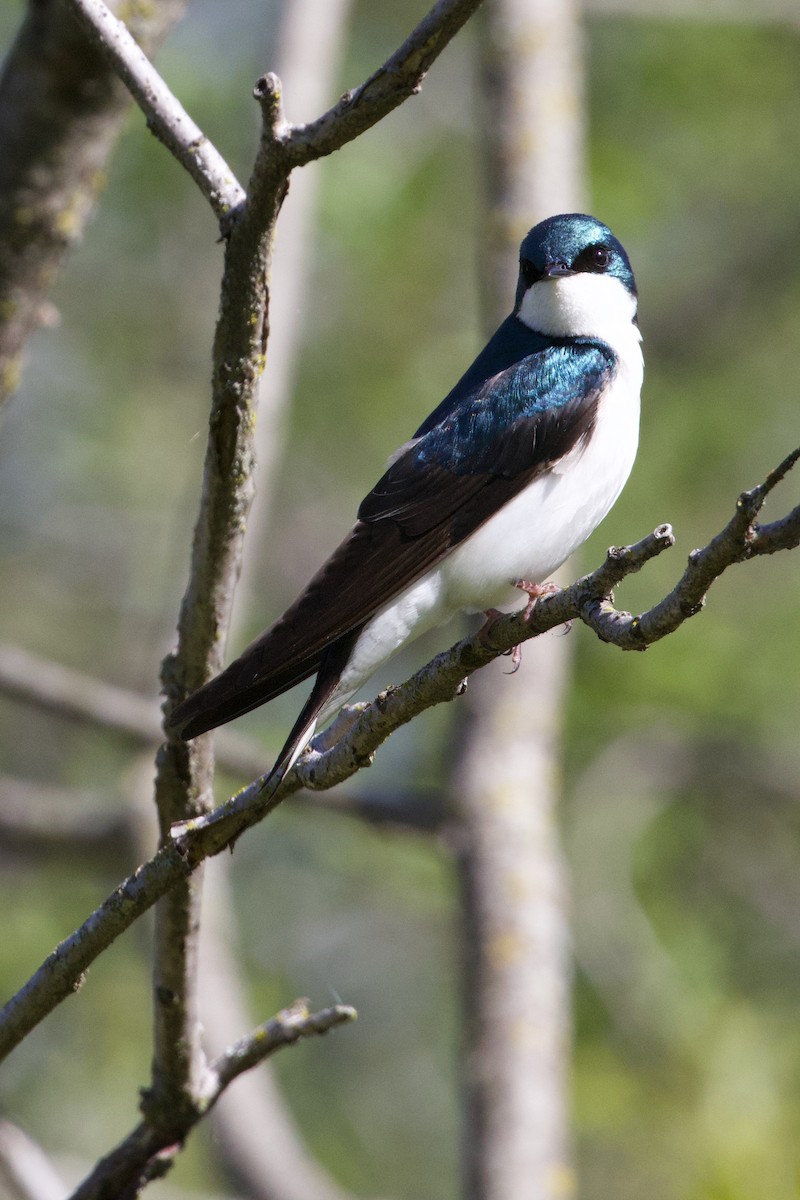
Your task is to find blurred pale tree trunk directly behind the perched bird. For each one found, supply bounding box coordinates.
[452,0,584,1200]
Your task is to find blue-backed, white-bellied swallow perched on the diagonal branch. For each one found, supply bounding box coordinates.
[170,212,643,786]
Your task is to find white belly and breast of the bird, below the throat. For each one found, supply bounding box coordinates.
[320,344,642,720]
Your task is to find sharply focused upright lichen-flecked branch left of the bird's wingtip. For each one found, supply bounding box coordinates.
[145,77,289,1127]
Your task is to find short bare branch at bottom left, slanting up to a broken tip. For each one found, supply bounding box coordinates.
[71,1000,356,1200]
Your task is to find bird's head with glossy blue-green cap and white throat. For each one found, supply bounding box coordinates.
[515,212,638,344]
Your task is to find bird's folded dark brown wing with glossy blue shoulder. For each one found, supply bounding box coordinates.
[172,333,614,738]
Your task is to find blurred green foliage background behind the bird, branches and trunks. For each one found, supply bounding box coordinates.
[0,0,800,1200]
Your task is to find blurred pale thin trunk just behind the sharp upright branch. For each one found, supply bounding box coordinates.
[206,0,359,1200]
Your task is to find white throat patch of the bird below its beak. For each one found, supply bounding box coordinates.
[517,271,642,355]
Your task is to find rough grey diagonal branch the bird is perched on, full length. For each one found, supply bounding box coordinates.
[0,450,800,1060]
